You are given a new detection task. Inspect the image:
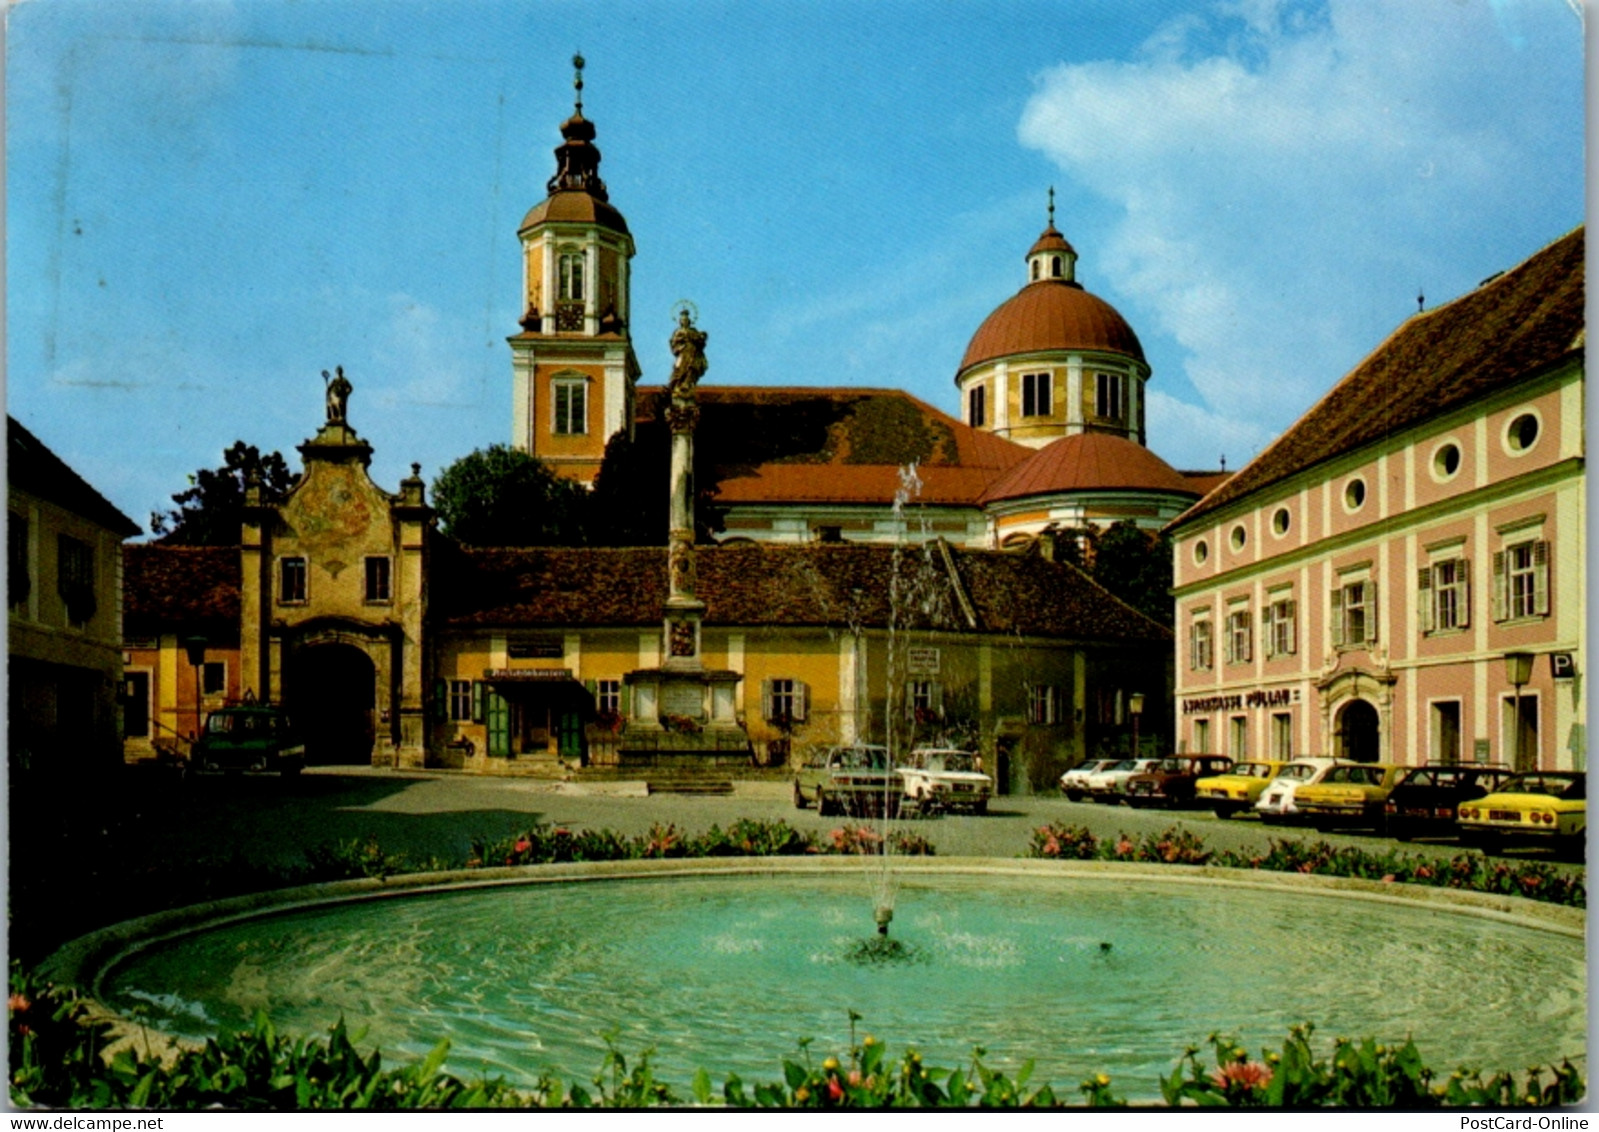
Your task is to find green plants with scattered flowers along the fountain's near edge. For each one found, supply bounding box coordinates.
[21,964,1586,1110]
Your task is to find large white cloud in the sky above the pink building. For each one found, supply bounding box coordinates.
[1019,0,1581,464]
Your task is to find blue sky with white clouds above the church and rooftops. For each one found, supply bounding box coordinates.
[6,0,1585,534]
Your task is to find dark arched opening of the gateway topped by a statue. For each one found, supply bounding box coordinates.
[283,643,377,764]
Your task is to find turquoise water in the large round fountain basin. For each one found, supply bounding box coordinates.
[102,875,1586,1097]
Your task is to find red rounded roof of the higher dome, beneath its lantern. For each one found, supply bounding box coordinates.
[961,280,1143,371]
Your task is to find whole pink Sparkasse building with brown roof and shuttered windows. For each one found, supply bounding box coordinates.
[1169,229,1586,769]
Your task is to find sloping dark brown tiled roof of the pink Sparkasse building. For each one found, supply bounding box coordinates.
[1172,227,1586,528]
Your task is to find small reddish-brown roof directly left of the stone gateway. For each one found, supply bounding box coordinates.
[122,542,240,636]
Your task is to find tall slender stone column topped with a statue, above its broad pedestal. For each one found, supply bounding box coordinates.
[662,307,705,670]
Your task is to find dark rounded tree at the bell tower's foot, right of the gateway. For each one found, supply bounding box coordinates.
[433,444,588,547]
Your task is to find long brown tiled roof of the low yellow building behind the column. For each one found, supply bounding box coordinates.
[444,544,1170,644]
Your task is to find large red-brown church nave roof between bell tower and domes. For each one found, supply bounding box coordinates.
[638,385,1031,507]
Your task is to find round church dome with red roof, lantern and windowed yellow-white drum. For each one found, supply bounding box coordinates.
[955,189,1150,448]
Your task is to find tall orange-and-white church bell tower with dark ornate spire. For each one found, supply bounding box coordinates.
[510,56,640,483]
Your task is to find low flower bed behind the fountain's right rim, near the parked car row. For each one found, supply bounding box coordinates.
[1025,823,1588,908]
